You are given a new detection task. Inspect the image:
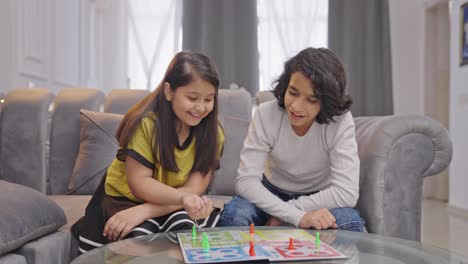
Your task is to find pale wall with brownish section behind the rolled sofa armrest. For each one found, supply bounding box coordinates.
[389,0,450,201]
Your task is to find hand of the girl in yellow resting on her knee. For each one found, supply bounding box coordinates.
[102,206,146,240]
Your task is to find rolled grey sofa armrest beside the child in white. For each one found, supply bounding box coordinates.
[355,115,452,241]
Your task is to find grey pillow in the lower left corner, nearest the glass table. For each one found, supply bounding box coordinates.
[0,180,67,255]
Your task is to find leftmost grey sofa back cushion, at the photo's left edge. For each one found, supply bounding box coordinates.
[0,88,53,192]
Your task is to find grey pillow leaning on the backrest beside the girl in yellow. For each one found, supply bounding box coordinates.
[68,109,123,194]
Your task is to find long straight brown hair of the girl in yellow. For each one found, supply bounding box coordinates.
[117,51,219,174]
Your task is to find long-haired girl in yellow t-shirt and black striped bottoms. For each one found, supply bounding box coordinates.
[72,52,224,253]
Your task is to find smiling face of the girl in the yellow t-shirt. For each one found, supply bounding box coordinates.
[164,78,216,131]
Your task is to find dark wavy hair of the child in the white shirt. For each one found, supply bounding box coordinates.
[273,48,352,124]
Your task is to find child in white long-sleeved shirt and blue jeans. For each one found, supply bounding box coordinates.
[220,48,364,231]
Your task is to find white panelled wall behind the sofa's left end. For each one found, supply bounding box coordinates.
[0,0,127,93]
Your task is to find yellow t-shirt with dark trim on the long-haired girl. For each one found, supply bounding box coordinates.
[105,113,224,202]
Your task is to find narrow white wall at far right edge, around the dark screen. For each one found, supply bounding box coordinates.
[449,0,468,209]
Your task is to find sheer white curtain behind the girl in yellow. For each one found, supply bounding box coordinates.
[127,0,182,90]
